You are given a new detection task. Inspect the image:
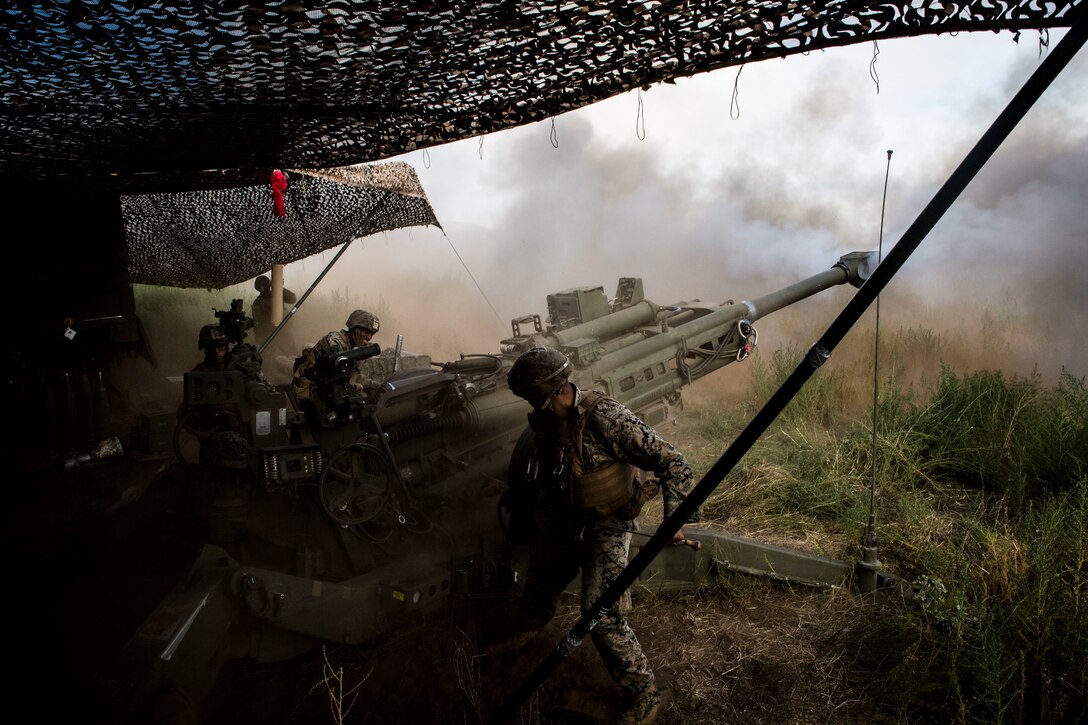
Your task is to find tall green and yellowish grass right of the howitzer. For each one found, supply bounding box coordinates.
[678,348,1088,723]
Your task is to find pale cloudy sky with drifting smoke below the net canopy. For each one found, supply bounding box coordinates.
[286,30,1088,376]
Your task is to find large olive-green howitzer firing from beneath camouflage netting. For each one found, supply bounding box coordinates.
[97,253,876,720]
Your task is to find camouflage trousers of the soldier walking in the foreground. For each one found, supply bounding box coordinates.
[522,512,654,693]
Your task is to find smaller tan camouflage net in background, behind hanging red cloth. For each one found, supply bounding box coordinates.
[121,163,438,288]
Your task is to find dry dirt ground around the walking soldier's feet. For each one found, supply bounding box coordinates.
[198,583,900,725]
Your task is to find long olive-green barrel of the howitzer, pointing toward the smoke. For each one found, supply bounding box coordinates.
[577,253,875,410]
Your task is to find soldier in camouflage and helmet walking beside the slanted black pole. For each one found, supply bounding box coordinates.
[507,347,694,723]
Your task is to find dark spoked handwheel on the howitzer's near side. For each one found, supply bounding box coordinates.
[318,443,399,527]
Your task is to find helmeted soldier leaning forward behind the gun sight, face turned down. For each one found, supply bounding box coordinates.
[292,309,382,405]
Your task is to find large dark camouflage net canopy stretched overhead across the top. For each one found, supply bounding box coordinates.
[0,0,1083,193]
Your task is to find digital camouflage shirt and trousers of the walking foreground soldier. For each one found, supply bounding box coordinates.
[522,383,694,695]
